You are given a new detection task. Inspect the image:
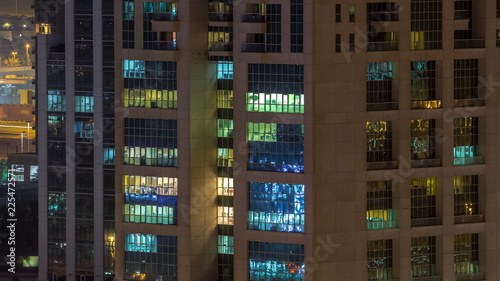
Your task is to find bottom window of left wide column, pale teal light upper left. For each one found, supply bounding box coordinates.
[124,233,178,281]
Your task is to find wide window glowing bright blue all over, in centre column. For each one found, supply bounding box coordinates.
[248,182,304,232]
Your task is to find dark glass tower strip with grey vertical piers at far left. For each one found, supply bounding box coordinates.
[34,0,115,280]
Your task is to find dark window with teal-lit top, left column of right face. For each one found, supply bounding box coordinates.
[366,62,393,104]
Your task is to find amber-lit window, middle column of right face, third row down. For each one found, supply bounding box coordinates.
[411,119,436,160]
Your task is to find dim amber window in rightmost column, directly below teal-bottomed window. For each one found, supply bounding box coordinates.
[453,175,479,216]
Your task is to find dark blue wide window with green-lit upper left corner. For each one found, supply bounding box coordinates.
[247,123,304,173]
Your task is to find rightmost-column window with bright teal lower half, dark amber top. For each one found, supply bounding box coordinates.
[453,117,484,165]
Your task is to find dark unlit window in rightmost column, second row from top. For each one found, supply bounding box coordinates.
[453,59,479,100]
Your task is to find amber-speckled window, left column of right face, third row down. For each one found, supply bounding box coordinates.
[366,121,392,162]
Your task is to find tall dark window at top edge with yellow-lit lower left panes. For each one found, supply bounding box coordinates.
[410,0,443,50]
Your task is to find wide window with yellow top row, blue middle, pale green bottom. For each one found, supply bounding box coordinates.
[123,175,177,224]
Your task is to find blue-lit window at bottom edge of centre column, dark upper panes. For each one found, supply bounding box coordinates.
[248,241,305,281]
